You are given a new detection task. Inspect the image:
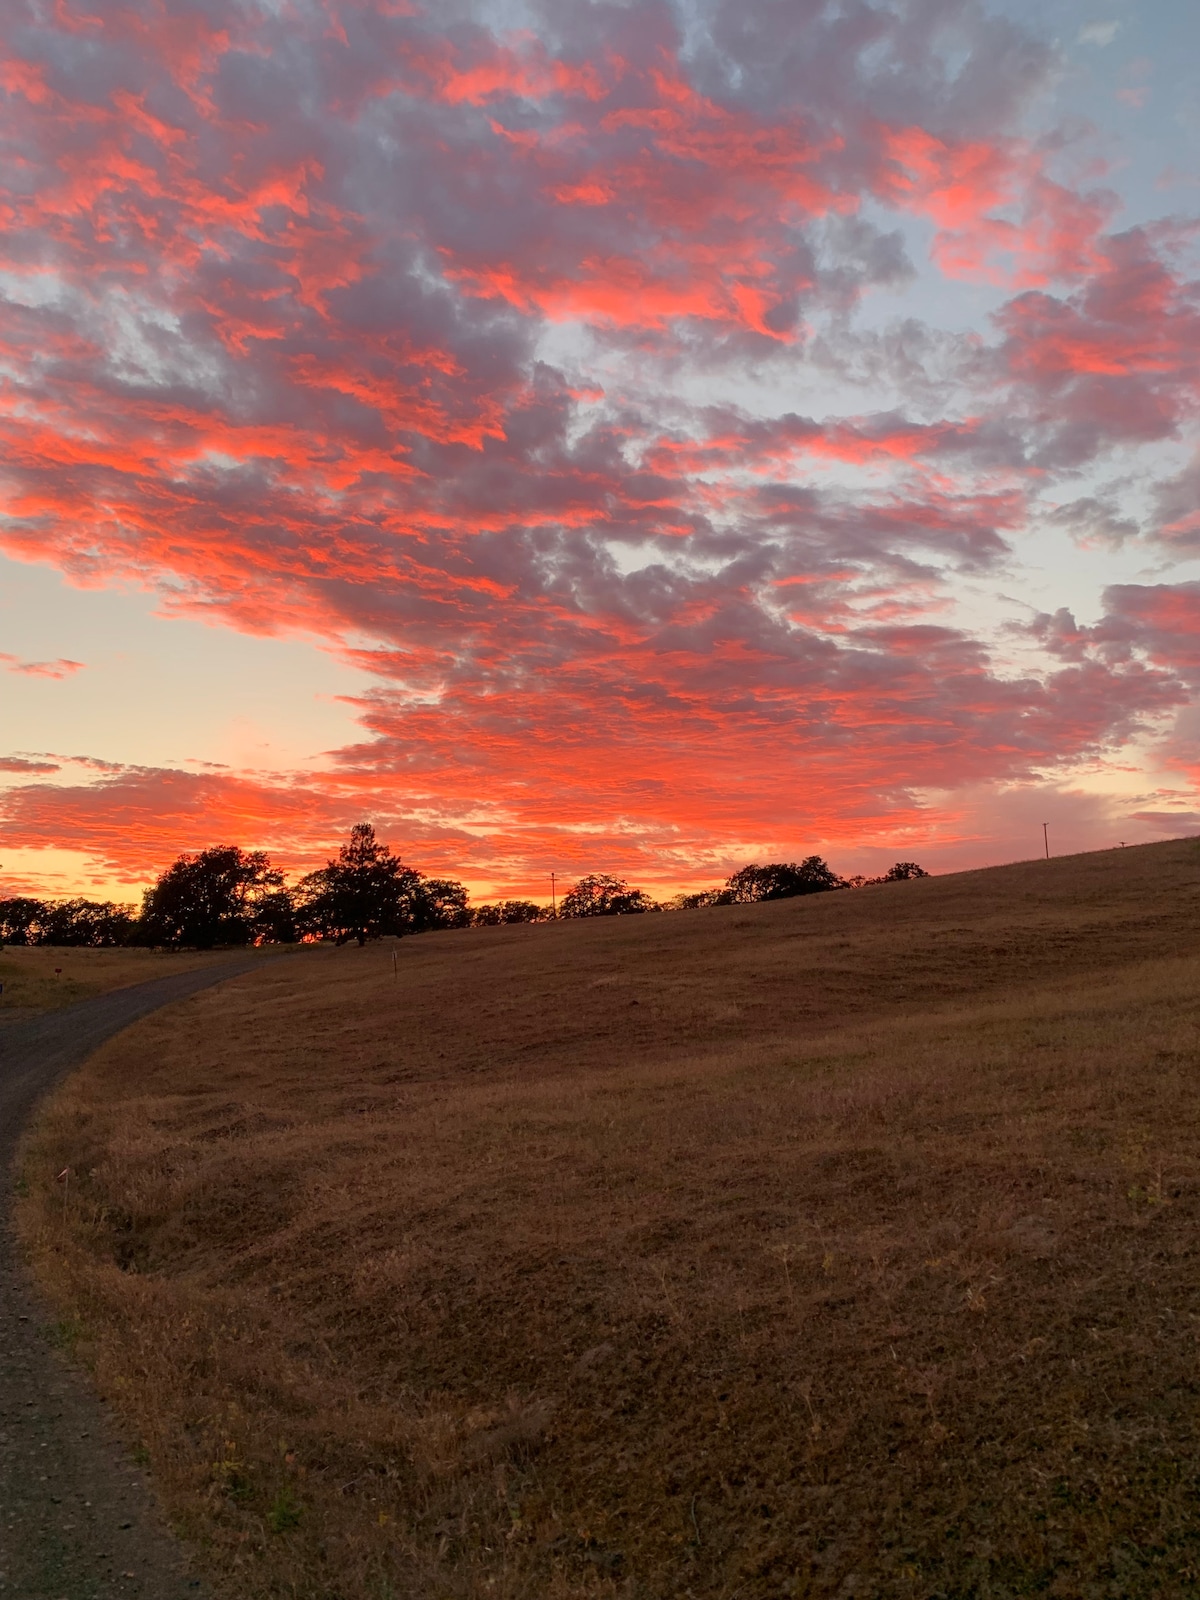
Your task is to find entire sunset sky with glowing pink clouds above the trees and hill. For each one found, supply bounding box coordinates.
[0,0,1200,899]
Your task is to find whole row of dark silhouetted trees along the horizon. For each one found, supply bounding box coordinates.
[0,822,928,950]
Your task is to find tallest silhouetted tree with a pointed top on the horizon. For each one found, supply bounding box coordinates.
[296,822,438,944]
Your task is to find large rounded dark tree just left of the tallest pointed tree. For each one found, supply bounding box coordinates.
[138,845,285,950]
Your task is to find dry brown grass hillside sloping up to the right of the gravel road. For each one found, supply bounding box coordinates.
[21,842,1200,1600]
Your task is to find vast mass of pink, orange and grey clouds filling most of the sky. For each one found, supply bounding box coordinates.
[0,0,1200,888]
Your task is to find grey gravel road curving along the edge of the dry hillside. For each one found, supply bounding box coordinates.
[0,957,261,1600]
